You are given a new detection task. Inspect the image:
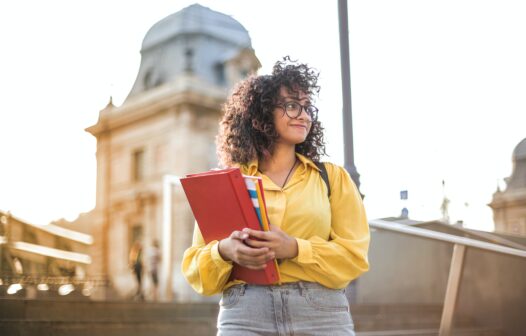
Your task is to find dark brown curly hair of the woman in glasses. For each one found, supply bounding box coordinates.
[216,56,326,167]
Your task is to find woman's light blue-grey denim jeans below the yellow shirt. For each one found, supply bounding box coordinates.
[217,282,354,336]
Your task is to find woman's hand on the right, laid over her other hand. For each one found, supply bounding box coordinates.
[243,225,298,259]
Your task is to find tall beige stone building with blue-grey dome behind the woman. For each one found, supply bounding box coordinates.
[82,4,260,300]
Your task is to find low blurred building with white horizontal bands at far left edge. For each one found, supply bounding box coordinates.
[0,211,93,298]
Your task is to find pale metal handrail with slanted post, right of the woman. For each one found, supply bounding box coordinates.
[369,219,526,336]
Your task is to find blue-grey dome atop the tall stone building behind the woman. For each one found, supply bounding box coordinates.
[125,4,259,103]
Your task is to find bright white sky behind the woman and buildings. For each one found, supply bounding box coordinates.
[0,0,526,230]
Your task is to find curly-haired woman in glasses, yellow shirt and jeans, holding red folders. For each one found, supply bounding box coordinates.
[182,58,369,335]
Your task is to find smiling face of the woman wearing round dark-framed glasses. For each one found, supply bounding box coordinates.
[273,87,312,145]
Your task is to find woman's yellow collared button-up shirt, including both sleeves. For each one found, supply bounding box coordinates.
[182,154,370,295]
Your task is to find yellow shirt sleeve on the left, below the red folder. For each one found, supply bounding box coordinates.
[182,225,232,295]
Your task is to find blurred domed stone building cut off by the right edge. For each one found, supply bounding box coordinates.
[489,138,526,235]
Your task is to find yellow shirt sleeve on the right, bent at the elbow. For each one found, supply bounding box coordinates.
[292,164,370,288]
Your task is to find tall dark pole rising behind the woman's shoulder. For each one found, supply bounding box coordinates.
[338,0,364,198]
